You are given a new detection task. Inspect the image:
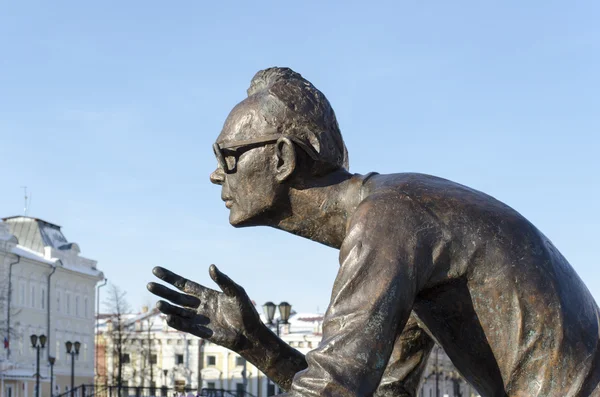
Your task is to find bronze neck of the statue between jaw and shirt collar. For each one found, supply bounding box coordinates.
[273,170,362,248]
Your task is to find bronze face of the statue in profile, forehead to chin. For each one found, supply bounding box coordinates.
[210,98,282,227]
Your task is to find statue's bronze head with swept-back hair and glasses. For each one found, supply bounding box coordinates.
[210,68,348,226]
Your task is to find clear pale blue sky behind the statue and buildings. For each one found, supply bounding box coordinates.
[0,0,600,312]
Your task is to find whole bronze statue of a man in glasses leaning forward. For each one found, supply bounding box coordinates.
[148,68,600,397]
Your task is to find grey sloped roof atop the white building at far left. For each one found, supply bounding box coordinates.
[2,216,70,253]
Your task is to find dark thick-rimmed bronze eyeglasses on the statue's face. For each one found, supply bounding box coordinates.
[213,134,319,174]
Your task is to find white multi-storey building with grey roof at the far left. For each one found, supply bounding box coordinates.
[0,216,104,397]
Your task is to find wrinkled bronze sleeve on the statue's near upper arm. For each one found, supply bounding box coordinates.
[289,196,434,396]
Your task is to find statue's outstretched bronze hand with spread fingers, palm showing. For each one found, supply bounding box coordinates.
[147,265,262,351]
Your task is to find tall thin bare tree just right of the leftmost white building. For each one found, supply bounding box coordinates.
[104,284,131,396]
